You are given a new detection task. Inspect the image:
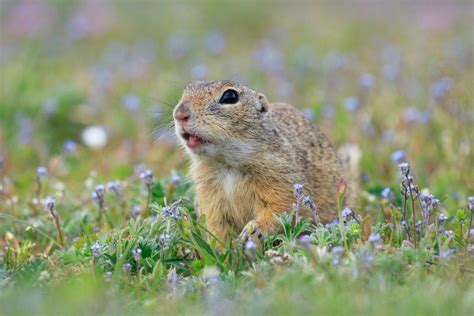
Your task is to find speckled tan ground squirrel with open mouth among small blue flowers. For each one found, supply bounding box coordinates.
[173,81,355,240]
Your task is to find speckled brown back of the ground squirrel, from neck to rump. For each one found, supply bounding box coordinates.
[269,103,356,222]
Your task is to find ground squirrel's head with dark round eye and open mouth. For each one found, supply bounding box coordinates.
[173,81,269,160]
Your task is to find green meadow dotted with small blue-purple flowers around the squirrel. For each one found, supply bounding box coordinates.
[0,0,474,315]
